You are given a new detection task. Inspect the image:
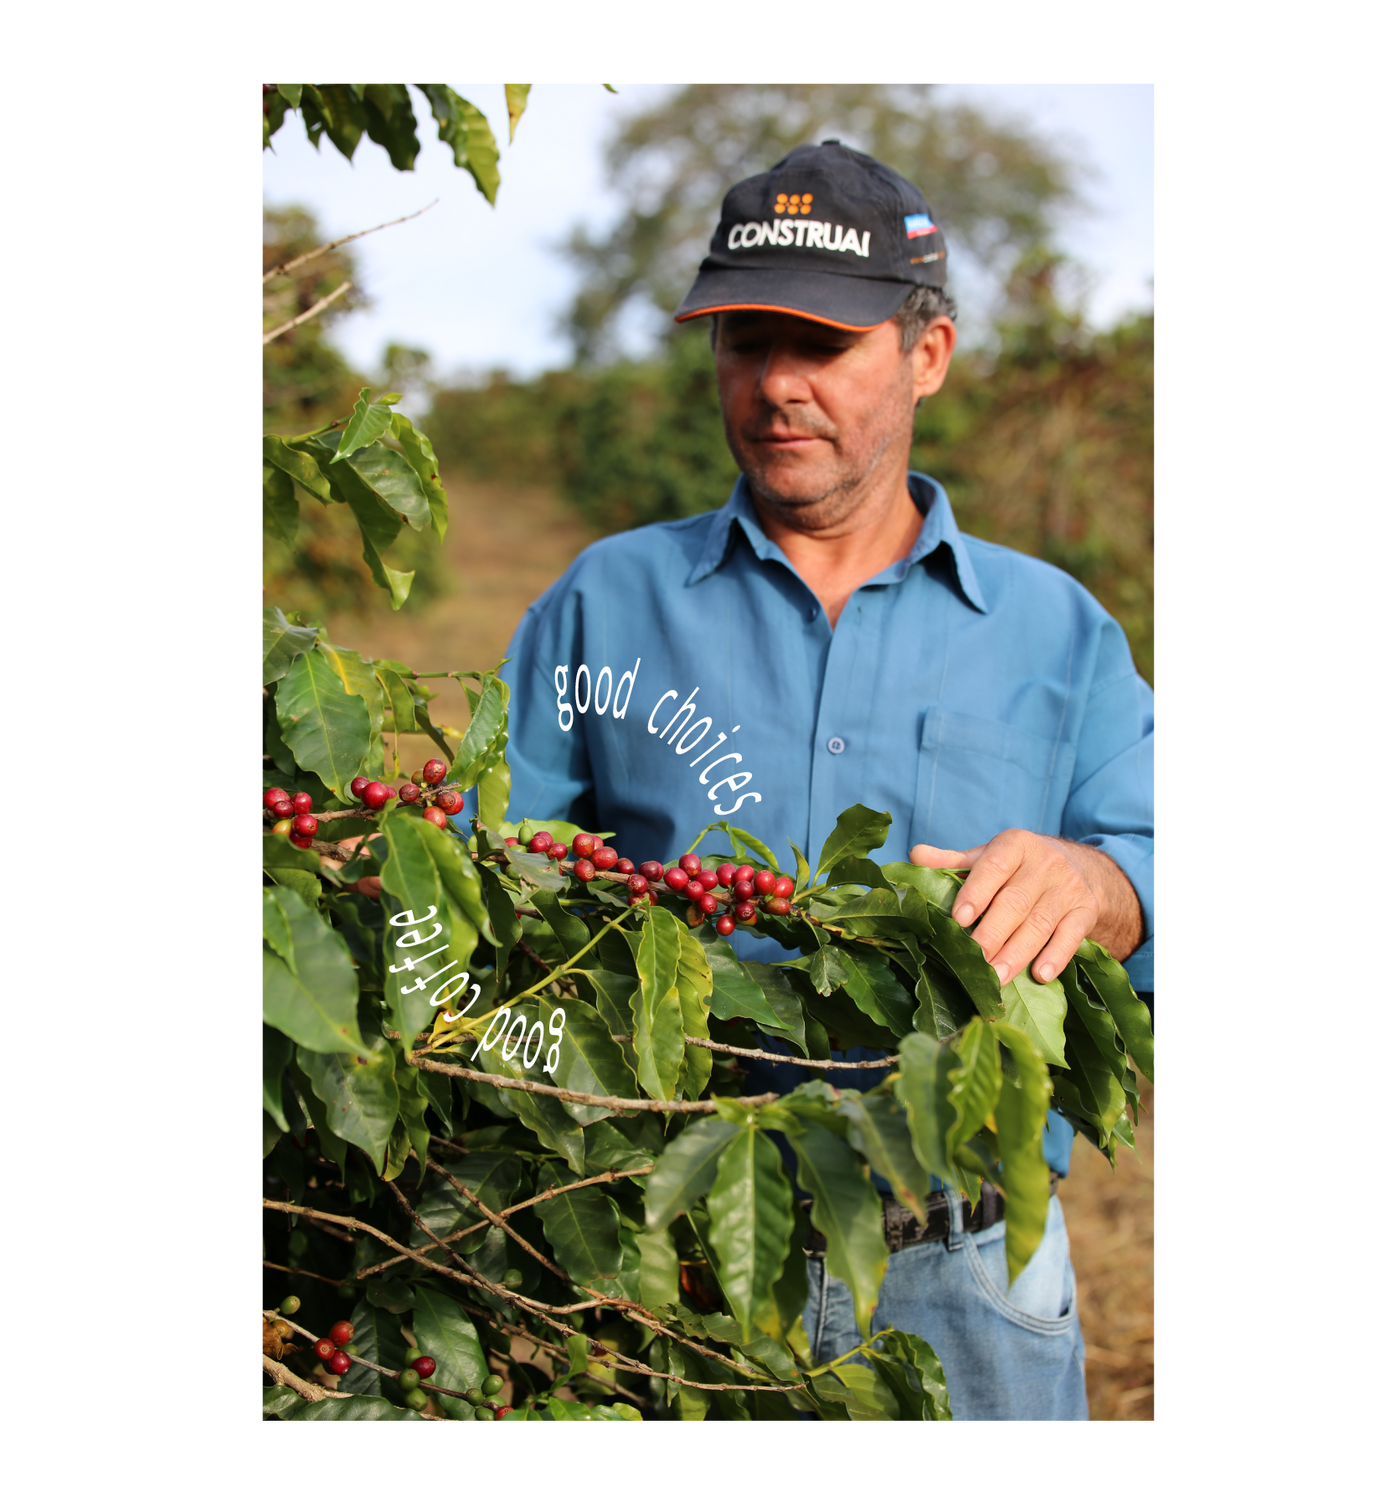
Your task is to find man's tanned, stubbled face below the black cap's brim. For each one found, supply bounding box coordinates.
[714,310,952,530]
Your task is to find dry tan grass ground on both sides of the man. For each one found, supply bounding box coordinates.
[329,478,1157,1423]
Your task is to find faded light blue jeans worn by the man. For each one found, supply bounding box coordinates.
[802,1198,1090,1423]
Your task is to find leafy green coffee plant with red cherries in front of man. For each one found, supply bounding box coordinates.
[258,602,1156,1423]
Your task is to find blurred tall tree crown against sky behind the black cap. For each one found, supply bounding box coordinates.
[564,78,1078,362]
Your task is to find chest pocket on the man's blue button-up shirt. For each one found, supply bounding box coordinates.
[909,707,1074,848]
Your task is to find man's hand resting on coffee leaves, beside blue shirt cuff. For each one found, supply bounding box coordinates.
[909,827,1142,984]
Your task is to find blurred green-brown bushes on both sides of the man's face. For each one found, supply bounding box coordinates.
[423,250,1157,684]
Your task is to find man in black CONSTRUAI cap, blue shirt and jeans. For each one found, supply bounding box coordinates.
[508,142,1156,1421]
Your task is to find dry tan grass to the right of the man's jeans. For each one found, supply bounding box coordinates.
[1059,1088,1157,1423]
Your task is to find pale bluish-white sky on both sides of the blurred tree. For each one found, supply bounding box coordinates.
[259,80,1157,377]
